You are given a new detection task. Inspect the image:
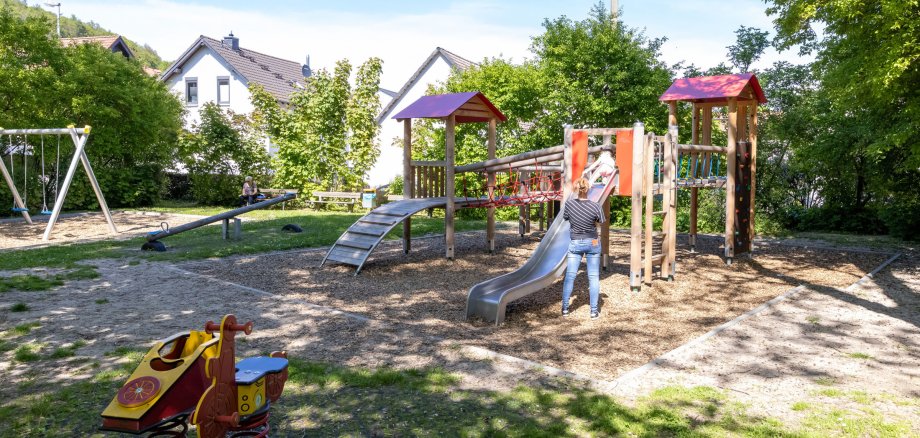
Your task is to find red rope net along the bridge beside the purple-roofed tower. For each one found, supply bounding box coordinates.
[461,160,563,208]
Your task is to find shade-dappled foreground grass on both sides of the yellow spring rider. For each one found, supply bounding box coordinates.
[0,349,797,437]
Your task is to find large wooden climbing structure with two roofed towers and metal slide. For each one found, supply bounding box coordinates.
[323,74,766,323]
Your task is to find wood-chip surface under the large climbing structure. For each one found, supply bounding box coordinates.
[186,232,887,379]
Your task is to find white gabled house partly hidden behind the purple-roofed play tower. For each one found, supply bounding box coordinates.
[368,47,477,186]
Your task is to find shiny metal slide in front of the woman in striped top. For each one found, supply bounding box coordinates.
[466,173,618,325]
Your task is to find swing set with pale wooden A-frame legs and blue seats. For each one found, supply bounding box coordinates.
[0,125,118,241]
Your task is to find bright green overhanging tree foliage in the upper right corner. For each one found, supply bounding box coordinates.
[767,0,920,170]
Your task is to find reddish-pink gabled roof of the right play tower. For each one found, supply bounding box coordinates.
[658,73,767,103]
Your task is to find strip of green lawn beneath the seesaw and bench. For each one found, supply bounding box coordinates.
[0,207,501,270]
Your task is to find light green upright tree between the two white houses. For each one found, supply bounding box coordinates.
[250,58,381,197]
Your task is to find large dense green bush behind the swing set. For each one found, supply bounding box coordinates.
[0,8,182,210]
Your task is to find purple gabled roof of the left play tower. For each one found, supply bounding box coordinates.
[393,91,508,123]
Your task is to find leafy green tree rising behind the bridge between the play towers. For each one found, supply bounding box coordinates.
[413,5,670,169]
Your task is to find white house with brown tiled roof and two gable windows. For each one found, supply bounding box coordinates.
[160,32,312,135]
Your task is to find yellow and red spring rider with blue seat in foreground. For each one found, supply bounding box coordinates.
[101,315,288,438]
